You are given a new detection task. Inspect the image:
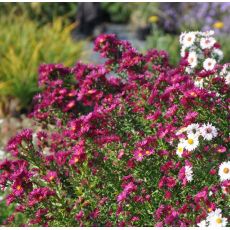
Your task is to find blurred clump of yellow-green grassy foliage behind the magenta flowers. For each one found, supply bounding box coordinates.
[0,16,83,115]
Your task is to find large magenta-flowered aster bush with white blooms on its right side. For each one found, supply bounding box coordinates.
[0,30,230,226]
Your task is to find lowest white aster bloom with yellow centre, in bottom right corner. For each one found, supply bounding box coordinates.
[207,209,228,227]
